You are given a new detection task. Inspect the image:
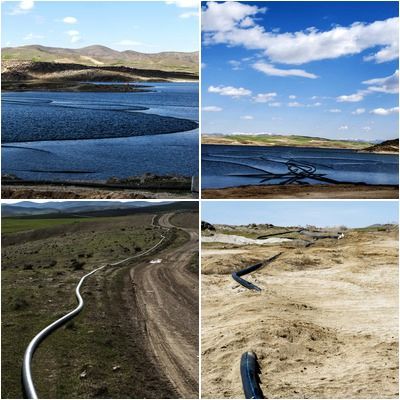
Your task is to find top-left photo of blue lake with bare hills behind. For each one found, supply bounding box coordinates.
[1,0,199,199]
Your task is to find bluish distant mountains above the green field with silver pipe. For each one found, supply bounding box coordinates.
[1,201,170,217]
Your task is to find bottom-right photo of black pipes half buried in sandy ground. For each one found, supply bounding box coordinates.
[201,201,399,399]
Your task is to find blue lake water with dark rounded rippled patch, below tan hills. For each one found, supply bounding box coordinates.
[2,83,198,180]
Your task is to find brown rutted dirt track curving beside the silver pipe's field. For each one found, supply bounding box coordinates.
[125,214,198,398]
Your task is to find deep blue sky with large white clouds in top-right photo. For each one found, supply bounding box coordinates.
[202,1,398,140]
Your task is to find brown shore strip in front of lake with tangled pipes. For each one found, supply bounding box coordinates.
[201,184,399,199]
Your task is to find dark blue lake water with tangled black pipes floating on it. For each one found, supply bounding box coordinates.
[201,145,399,189]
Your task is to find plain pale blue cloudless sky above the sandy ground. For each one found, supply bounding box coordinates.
[201,201,398,227]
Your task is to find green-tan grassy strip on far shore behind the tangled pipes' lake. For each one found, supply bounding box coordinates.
[202,135,372,150]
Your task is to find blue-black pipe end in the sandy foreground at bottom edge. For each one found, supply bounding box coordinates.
[240,351,264,399]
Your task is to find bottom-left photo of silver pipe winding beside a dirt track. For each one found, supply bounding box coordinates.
[1,200,199,399]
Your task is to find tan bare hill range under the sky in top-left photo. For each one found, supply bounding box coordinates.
[1,45,199,74]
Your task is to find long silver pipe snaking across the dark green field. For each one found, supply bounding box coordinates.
[22,230,169,399]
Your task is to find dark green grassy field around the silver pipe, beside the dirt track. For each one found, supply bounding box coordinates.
[1,214,176,398]
